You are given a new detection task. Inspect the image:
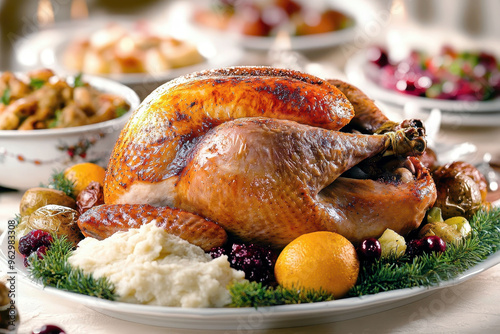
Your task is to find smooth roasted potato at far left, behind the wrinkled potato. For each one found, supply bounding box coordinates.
[19,187,76,217]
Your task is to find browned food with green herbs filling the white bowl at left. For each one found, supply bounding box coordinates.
[0,69,130,130]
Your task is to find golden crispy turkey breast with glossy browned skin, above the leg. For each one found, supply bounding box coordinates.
[104,67,354,205]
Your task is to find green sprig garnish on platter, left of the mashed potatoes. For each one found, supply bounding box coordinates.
[29,235,116,300]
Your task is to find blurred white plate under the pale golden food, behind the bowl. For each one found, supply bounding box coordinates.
[14,17,243,99]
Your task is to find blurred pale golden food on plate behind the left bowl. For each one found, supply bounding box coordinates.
[62,22,205,75]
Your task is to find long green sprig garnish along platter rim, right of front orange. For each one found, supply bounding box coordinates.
[348,208,500,296]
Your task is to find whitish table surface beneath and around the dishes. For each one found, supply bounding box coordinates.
[0,39,500,334]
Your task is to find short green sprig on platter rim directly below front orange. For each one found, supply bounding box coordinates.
[229,282,333,307]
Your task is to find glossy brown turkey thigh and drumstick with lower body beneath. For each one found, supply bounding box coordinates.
[174,118,435,247]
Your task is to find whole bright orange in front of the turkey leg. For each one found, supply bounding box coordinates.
[274,231,359,299]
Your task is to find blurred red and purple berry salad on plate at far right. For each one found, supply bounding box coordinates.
[366,46,500,101]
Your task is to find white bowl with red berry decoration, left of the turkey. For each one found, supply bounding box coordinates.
[0,76,140,190]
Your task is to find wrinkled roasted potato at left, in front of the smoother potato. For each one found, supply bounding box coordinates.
[27,204,83,245]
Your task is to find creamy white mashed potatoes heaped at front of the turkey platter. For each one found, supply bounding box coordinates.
[69,222,245,307]
